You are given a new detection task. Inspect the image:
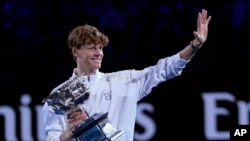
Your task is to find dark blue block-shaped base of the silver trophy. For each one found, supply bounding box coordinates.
[73,113,124,141]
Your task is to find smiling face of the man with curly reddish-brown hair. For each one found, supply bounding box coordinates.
[74,44,103,73]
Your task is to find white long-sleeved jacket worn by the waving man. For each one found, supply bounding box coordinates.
[43,53,189,141]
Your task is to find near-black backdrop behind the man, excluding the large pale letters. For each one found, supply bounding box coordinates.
[0,0,250,140]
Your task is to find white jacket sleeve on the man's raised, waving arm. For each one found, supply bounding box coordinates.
[137,53,189,100]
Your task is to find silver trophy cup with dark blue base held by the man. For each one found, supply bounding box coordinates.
[43,74,124,141]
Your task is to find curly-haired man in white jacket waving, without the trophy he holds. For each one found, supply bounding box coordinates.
[43,9,211,141]
